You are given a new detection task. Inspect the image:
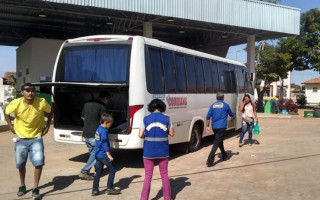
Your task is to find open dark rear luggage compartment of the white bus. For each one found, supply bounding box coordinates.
[54,86,128,134]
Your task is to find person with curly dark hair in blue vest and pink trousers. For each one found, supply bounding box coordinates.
[139,99,174,200]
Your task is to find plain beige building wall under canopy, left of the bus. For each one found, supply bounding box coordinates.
[17,38,63,91]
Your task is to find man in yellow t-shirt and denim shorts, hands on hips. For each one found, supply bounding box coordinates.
[5,83,53,199]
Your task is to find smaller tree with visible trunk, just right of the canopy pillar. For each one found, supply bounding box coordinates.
[255,43,291,112]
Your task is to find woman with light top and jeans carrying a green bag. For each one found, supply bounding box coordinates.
[239,94,258,147]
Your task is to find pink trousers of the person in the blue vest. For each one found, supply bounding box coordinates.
[141,158,171,200]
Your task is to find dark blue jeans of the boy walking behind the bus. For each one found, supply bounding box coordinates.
[92,158,116,192]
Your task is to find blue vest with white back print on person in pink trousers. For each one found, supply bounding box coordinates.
[143,112,170,159]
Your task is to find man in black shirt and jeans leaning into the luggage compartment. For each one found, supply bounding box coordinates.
[79,91,110,180]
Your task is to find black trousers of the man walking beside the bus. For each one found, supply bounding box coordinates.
[207,128,227,163]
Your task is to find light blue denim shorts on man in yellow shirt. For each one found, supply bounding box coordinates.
[14,137,44,169]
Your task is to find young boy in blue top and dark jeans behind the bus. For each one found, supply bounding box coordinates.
[91,113,120,196]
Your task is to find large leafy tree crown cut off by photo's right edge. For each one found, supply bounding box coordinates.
[279,8,320,71]
